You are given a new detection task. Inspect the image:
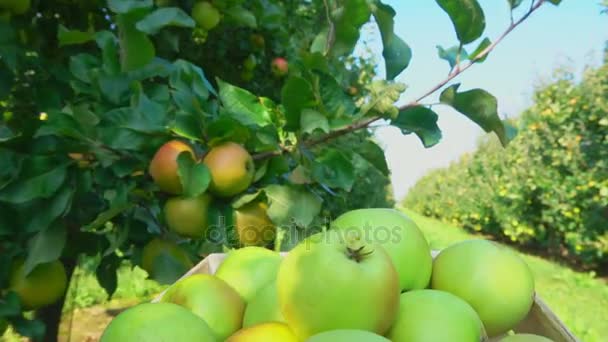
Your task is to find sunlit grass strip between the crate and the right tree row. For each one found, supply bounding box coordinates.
[404,209,608,342]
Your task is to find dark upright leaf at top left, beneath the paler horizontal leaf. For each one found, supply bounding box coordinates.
[116,12,156,71]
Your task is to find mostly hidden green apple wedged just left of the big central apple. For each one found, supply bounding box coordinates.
[243,281,285,328]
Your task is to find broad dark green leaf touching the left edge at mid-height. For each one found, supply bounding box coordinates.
[0,165,67,204]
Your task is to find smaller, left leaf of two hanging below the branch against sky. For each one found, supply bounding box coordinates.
[391,106,441,148]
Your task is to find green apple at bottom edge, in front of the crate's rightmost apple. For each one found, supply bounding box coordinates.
[386,290,483,342]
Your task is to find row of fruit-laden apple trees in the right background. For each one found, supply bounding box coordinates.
[404,64,608,268]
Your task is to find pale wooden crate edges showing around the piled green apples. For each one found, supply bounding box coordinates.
[153,251,579,342]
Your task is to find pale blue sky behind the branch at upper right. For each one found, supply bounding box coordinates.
[364,0,608,198]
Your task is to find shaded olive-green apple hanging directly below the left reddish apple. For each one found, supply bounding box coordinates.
[164,194,211,239]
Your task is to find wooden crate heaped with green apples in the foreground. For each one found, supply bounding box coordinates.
[101,209,577,342]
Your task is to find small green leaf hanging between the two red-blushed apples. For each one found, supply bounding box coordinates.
[177,152,211,197]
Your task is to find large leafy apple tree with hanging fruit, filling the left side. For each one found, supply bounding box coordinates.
[0,0,560,341]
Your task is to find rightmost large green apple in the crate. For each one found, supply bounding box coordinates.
[431,240,534,336]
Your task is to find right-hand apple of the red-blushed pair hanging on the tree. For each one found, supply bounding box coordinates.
[203,142,255,197]
